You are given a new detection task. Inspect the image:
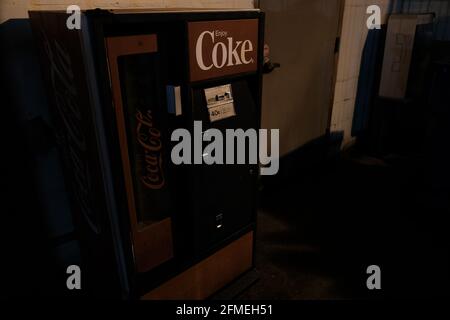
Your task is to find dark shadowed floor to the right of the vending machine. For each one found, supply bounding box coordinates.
[238,150,450,300]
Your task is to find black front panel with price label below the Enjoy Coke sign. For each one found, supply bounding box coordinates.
[193,80,258,252]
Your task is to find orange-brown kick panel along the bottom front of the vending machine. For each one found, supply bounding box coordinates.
[142,232,253,300]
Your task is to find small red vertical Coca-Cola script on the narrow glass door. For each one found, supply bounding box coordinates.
[136,110,165,189]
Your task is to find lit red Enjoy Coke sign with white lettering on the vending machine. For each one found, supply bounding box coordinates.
[188,19,258,81]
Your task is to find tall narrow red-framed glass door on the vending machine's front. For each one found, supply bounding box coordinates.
[106,34,173,272]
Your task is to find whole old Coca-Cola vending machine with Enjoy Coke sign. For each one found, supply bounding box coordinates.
[30,9,264,299]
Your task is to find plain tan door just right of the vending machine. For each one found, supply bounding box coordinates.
[260,0,341,156]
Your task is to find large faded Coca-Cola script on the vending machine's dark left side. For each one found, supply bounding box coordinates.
[39,30,101,234]
